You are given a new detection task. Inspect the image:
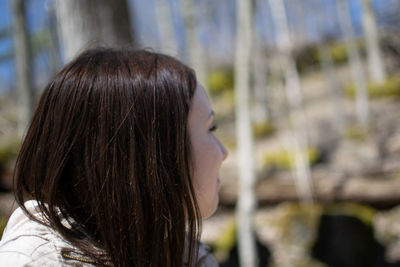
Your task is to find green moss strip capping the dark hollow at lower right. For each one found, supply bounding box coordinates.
[324,202,376,226]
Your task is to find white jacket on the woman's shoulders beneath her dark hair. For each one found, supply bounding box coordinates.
[0,200,218,267]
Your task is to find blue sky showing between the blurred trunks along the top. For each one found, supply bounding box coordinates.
[0,0,400,92]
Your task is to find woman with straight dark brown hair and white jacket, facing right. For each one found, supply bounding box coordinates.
[0,49,227,267]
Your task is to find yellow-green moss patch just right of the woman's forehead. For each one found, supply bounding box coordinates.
[208,70,233,95]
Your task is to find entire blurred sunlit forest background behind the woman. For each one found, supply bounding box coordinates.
[0,0,400,267]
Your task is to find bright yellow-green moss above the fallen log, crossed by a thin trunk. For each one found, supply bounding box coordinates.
[264,147,320,169]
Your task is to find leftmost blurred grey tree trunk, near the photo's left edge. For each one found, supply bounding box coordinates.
[12,0,34,137]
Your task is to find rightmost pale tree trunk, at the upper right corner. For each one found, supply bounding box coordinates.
[362,0,386,83]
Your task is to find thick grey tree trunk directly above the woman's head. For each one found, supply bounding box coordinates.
[55,0,134,61]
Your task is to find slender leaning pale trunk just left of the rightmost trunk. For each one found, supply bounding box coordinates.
[338,0,369,129]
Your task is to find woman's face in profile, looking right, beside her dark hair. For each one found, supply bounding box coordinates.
[188,84,228,219]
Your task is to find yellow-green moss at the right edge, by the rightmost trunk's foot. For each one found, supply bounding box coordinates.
[344,73,400,98]
